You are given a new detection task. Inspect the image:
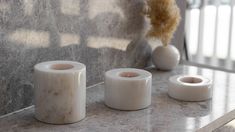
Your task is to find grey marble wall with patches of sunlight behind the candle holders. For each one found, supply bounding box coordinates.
[0,0,185,115]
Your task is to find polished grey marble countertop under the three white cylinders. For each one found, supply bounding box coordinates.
[0,66,235,132]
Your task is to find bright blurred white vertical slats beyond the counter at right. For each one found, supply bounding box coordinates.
[184,0,235,72]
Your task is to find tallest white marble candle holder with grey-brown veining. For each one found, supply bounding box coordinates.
[34,61,86,124]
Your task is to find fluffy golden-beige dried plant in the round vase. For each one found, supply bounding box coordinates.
[144,0,181,46]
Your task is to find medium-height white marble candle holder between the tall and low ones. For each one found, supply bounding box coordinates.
[105,68,152,110]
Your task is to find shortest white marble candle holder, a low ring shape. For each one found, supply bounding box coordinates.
[168,75,212,101]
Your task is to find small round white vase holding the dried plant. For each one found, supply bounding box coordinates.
[152,45,180,70]
